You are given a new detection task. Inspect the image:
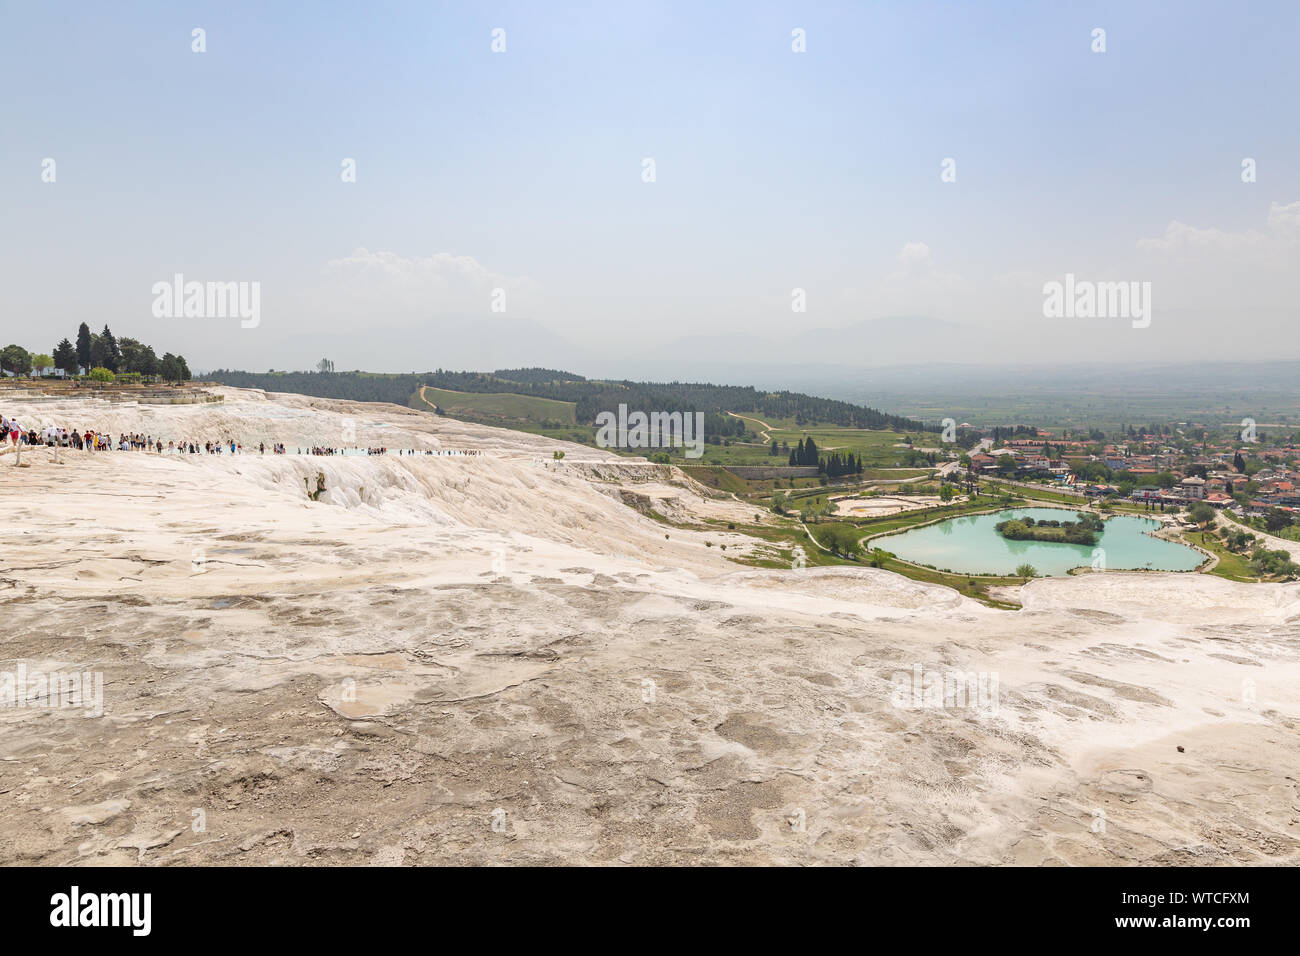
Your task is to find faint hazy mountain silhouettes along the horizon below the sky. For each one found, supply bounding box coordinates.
[194,311,1300,389]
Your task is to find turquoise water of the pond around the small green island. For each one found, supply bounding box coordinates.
[870,507,1205,578]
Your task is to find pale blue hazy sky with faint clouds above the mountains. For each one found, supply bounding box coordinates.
[0,0,1300,372]
